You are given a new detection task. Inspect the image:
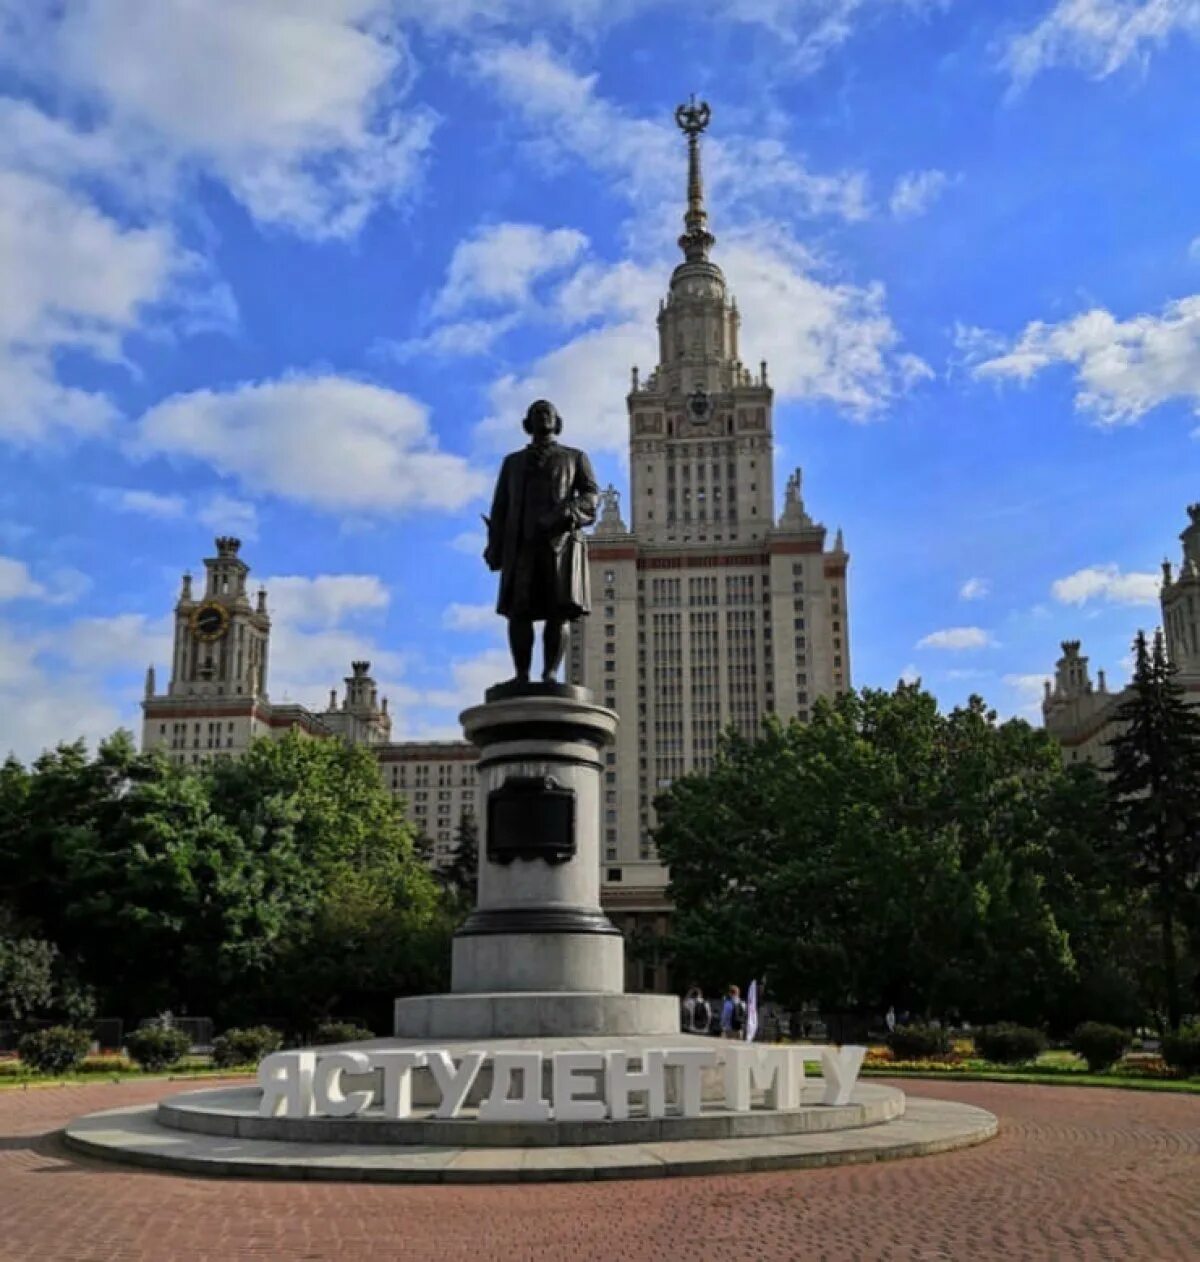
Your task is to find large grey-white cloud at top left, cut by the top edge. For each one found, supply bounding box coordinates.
[11,0,435,237]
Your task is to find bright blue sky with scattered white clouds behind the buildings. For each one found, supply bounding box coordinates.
[0,0,1200,756]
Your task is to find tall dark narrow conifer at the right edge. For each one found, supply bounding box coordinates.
[1109,631,1200,1030]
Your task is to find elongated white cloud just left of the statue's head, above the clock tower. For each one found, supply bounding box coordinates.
[138,376,488,512]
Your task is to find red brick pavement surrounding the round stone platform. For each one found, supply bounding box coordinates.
[0,1082,1200,1262]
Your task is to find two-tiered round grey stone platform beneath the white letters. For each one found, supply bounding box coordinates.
[64,1083,997,1182]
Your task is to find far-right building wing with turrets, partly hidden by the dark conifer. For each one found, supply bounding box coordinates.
[1042,504,1200,769]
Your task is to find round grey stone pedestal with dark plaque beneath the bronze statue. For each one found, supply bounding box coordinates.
[452,684,625,994]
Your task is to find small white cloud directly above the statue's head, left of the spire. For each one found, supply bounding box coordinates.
[434,223,588,316]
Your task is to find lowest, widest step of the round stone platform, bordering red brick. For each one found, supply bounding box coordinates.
[62,1099,998,1184]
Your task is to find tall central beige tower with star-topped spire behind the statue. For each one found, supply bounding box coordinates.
[569,101,850,989]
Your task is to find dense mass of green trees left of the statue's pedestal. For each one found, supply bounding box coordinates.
[0,733,450,1020]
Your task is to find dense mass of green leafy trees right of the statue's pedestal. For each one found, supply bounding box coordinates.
[657,684,1115,1020]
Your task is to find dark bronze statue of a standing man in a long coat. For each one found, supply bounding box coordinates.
[483,399,599,684]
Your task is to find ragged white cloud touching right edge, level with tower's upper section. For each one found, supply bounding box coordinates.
[973,294,1200,425]
